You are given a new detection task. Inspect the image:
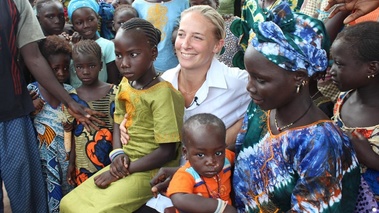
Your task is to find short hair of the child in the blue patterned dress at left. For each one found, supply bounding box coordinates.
[39,35,72,58]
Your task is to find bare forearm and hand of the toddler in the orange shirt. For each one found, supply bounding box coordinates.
[170,193,237,213]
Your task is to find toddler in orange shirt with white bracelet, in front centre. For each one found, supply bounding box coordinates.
[167,113,236,212]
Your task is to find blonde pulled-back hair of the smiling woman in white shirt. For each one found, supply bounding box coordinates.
[180,5,225,40]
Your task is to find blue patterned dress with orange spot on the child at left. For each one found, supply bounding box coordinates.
[28,82,76,212]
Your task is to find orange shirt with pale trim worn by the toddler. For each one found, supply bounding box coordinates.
[167,150,234,205]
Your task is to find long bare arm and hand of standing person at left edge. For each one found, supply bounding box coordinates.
[20,42,105,130]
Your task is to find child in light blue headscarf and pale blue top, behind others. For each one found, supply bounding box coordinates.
[67,0,120,88]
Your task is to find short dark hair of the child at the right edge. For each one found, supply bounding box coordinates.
[336,21,379,61]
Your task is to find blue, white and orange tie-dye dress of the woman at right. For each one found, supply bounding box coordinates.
[233,103,360,212]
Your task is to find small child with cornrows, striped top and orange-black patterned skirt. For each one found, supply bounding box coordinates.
[67,40,118,185]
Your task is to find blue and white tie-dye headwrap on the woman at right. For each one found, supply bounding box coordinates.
[252,1,330,76]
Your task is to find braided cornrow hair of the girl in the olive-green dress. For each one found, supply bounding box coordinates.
[120,18,161,46]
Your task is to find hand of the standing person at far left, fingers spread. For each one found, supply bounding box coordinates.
[68,100,106,131]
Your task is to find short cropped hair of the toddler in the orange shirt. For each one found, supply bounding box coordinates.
[182,113,226,145]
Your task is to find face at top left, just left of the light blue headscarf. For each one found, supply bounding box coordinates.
[37,1,65,35]
